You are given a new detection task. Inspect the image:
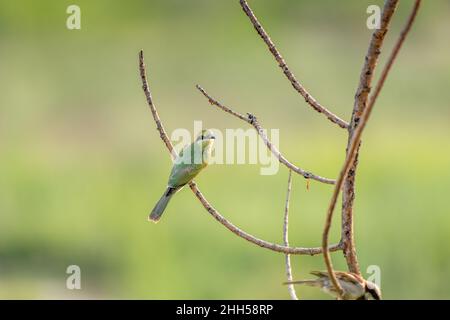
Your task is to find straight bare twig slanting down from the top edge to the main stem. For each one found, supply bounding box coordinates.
[240,0,349,129]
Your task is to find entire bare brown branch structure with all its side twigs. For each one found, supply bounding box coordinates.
[139,0,421,299]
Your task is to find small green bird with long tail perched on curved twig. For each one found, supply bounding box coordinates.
[149,130,215,223]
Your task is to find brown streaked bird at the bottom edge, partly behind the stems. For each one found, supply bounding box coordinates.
[284,271,381,300]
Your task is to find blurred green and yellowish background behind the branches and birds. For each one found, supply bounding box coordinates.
[0,0,450,299]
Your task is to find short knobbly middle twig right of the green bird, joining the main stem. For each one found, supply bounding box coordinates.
[196,85,336,184]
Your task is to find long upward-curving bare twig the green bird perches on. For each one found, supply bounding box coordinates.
[139,50,342,255]
